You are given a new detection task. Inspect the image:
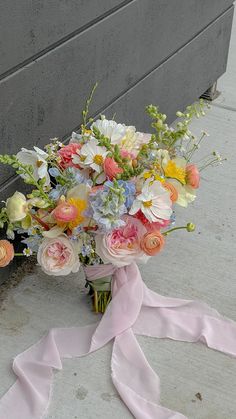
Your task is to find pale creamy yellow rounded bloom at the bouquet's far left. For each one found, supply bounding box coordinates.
[6,191,28,223]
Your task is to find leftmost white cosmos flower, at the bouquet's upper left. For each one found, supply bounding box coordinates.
[16,147,50,185]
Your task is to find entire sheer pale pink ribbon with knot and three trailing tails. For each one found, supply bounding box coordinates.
[0,263,236,419]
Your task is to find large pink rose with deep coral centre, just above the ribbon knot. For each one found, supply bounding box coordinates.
[95,215,147,267]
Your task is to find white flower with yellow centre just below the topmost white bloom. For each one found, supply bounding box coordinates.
[73,138,108,173]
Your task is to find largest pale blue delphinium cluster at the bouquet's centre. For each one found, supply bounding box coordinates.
[90,181,127,231]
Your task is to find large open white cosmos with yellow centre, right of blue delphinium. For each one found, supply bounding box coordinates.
[129,179,172,222]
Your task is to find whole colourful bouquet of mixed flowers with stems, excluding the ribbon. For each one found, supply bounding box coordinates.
[0,89,222,312]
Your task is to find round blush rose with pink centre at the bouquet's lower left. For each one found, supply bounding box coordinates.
[37,235,80,276]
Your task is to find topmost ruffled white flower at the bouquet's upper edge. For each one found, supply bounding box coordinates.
[91,119,127,144]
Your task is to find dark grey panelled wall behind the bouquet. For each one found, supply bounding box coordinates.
[0,0,233,282]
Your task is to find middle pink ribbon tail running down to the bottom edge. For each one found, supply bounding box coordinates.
[111,328,186,419]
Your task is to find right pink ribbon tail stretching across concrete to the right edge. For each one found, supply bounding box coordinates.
[134,288,236,356]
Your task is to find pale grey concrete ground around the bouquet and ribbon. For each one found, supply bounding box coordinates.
[0,16,236,419]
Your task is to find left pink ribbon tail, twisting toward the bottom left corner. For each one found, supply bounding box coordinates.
[0,324,98,419]
